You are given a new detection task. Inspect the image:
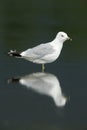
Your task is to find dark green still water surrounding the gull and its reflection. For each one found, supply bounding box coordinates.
[0,0,87,130]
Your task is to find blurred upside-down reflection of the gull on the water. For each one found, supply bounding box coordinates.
[9,72,67,107]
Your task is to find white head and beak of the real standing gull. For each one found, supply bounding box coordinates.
[56,32,72,43]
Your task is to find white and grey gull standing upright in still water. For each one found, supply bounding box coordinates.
[8,32,71,70]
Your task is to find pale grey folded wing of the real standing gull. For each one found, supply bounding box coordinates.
[21,43,55,59]
